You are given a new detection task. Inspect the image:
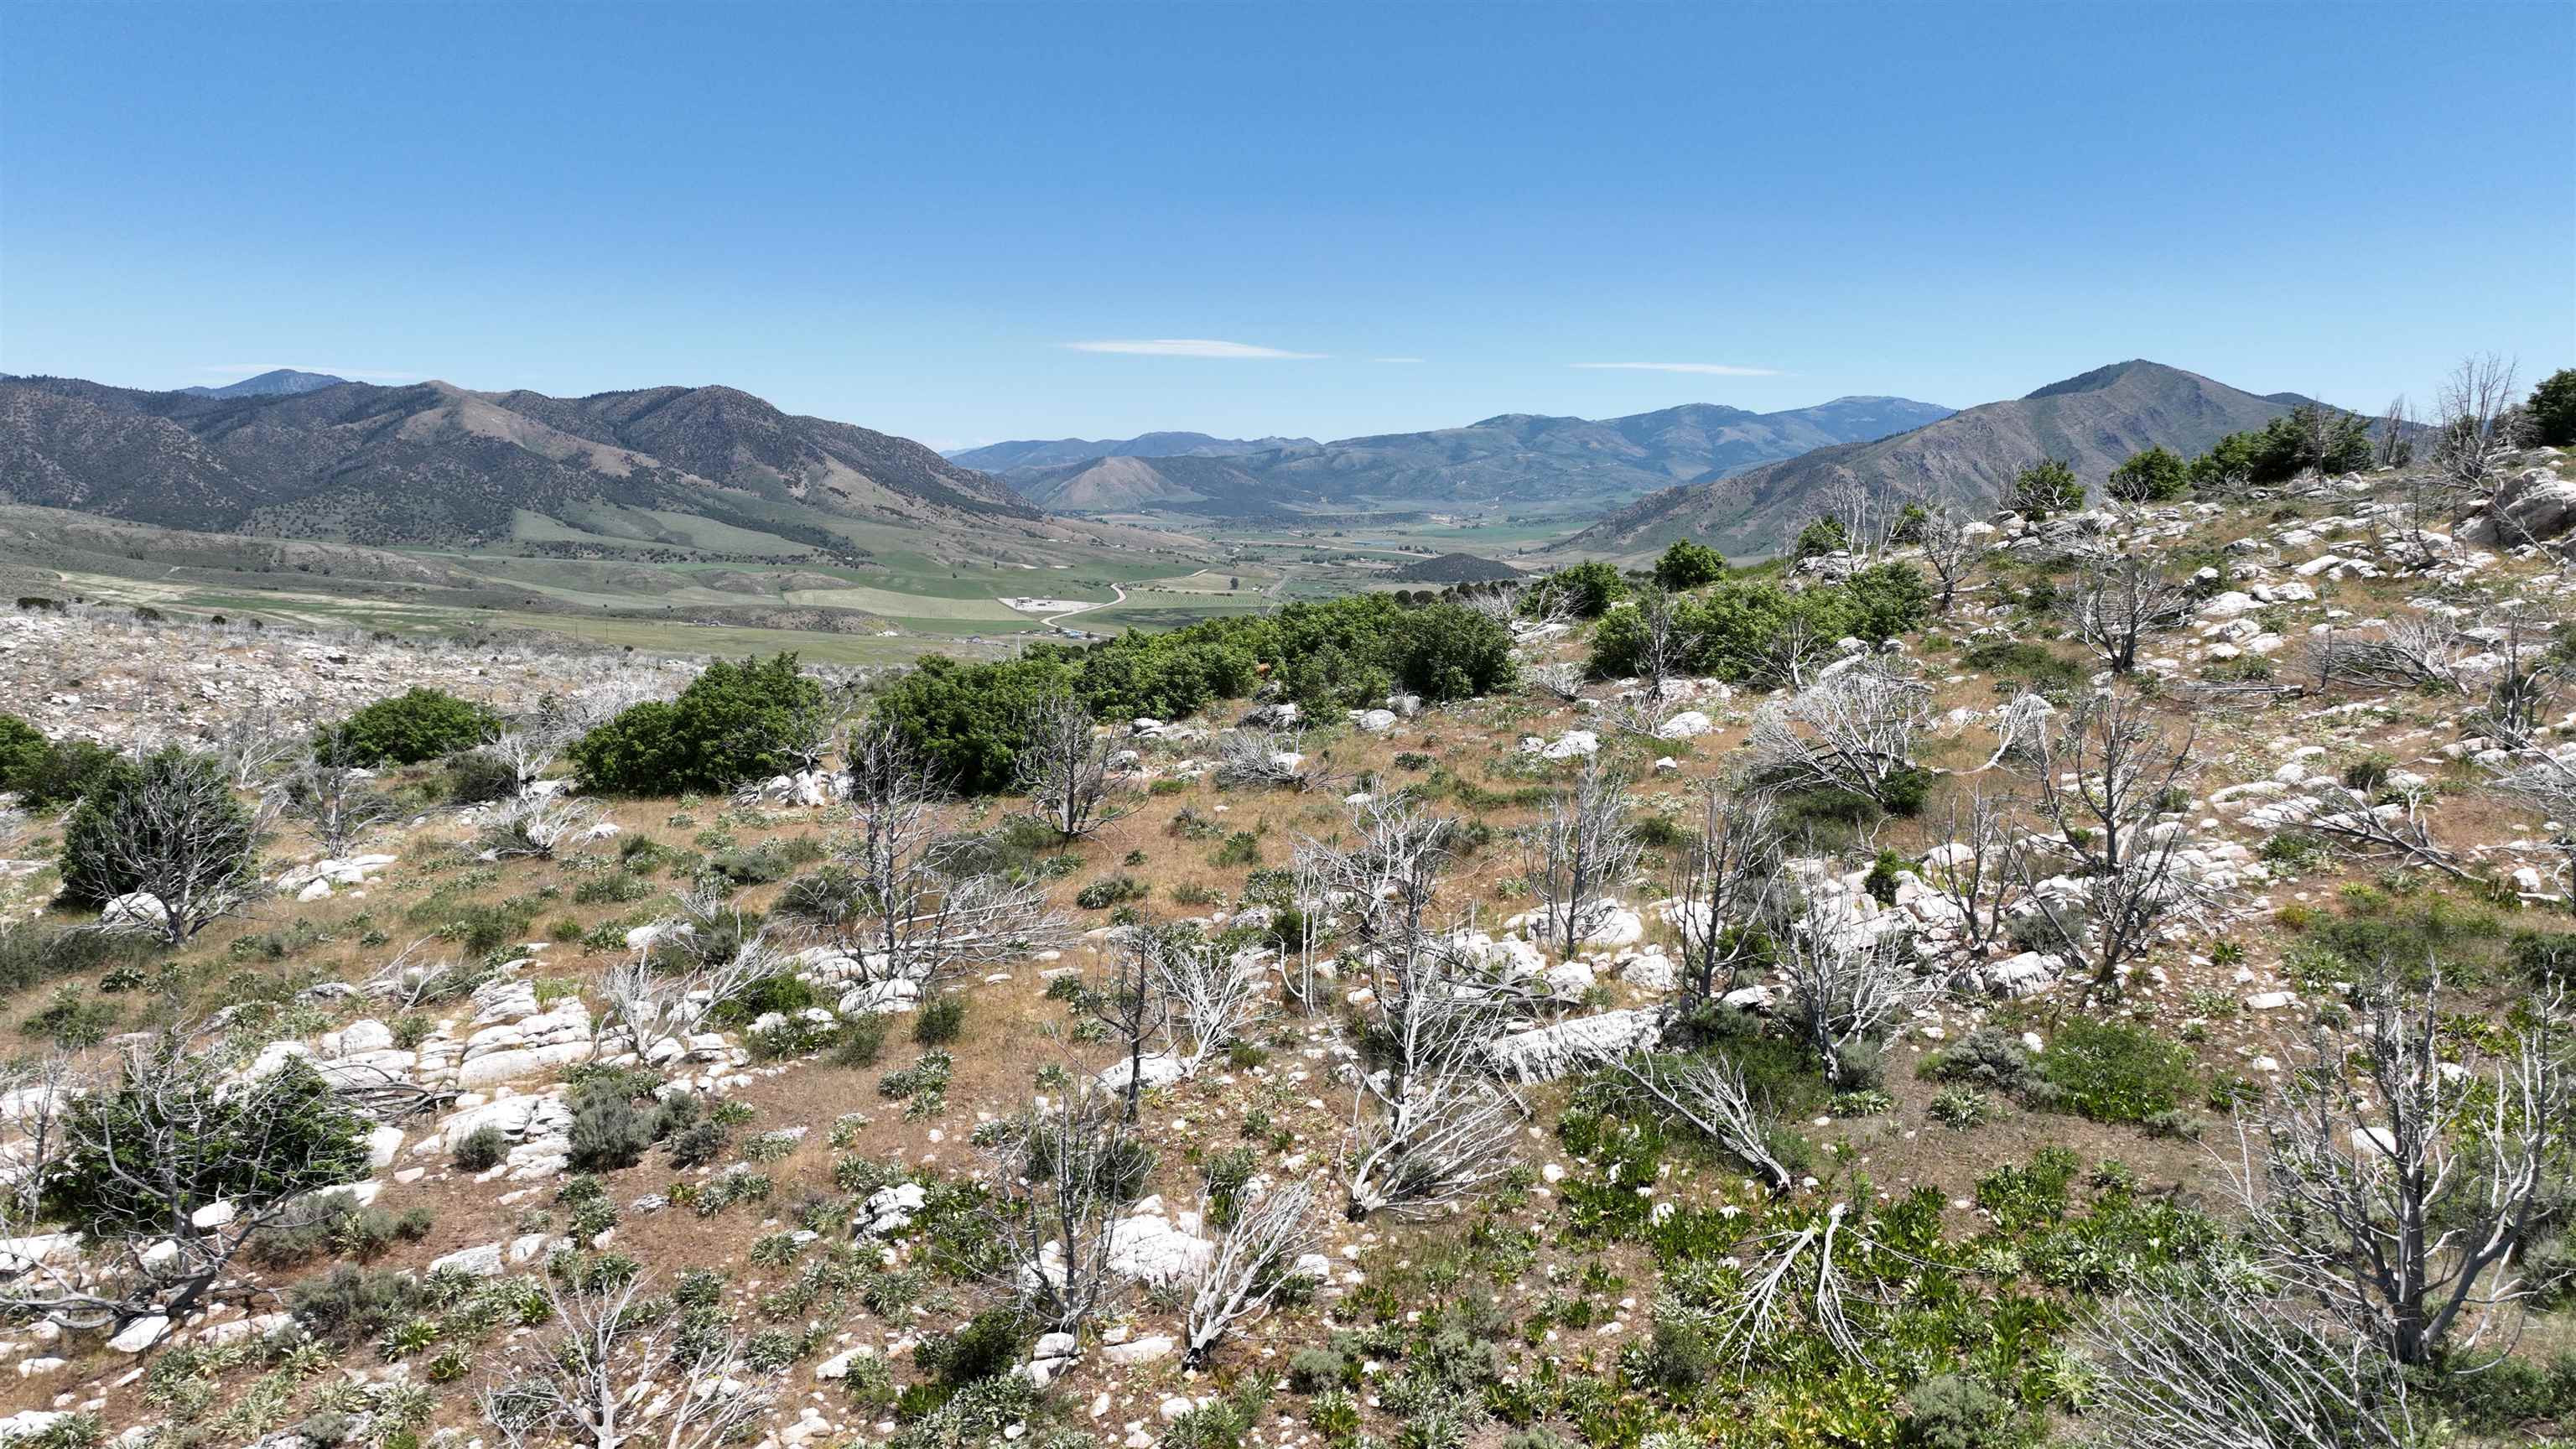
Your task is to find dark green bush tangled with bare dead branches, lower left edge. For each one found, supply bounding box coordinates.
[0,1029,373,1327]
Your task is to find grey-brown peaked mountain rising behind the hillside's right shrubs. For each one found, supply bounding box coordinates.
[1561,358,2339,554]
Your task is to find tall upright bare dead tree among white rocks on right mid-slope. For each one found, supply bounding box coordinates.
[2012,693,2205,993]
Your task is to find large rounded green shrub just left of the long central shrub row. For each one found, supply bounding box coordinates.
[567,655,824,794]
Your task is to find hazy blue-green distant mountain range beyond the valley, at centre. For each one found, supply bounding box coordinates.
[984,397,1950,516]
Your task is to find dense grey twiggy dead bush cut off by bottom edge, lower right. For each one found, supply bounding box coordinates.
[2084,1291,2422,1449]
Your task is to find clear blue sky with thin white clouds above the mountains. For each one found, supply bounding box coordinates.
[0,0,2576,446]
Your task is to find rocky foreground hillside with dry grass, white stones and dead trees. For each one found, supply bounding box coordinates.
[0,438,2576,1449]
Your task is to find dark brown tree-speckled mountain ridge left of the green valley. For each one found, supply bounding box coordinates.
[0,374,1041,549]
